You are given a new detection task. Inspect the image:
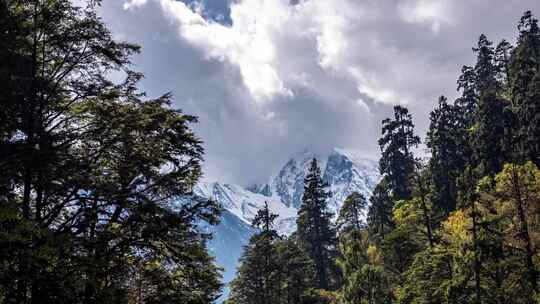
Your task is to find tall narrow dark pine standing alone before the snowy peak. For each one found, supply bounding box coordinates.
[296,159,336,289]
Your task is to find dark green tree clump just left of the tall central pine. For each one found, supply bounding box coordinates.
[227,205,314,304]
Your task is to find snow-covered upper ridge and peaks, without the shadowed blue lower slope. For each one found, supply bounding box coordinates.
[195,148,380,235]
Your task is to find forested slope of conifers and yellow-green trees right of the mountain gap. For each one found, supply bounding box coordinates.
[228,12,540,304]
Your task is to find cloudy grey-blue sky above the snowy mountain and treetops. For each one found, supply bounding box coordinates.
[100,0,540,185]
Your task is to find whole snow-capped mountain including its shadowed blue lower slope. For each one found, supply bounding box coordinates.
[202,148,380,302]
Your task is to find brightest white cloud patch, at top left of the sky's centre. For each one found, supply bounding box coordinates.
[160,0,292,101]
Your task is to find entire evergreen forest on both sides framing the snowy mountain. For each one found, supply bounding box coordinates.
[0,0,540,304]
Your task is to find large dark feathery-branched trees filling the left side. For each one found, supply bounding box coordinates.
[0,0,221,303]
